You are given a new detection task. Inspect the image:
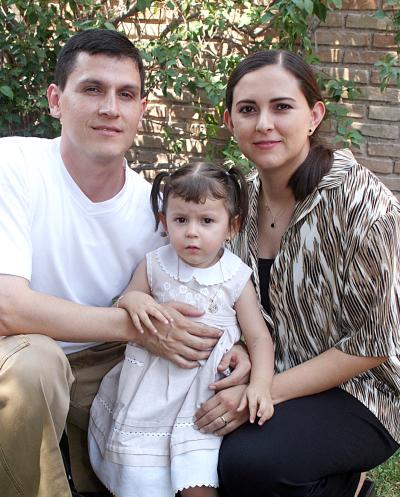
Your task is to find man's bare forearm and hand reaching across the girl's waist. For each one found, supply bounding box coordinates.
[0,275,220,367]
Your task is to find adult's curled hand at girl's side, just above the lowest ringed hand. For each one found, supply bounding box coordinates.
[208,342,251,392]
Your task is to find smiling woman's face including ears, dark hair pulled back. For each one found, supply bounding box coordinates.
[224,65,325,177]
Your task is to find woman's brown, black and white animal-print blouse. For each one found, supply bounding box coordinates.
[232,150,400,442]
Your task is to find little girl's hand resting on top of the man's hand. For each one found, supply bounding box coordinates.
[117,291,173,334]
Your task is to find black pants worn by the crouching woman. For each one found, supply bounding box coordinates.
[218,388,399,497]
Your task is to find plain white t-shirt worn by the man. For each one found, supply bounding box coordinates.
[0,137,164,354]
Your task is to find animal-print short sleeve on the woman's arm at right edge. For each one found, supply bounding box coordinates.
[336,210,400,357]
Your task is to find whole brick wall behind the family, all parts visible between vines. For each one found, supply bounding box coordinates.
[129,0,400,193]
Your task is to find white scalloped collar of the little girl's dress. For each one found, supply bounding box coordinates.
[156,245,241,285]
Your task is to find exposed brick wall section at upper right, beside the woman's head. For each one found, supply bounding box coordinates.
[315,0,400,193]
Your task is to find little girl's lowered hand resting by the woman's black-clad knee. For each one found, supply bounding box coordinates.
[237,380,274,426]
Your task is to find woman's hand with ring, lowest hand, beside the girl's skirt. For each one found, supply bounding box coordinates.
[194,385,249,436]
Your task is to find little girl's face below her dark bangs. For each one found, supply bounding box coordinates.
[160,194,233,267]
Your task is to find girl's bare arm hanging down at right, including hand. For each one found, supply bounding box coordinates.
[235,280,274,425]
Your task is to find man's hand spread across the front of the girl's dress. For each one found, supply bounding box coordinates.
[134,302,222,368]
